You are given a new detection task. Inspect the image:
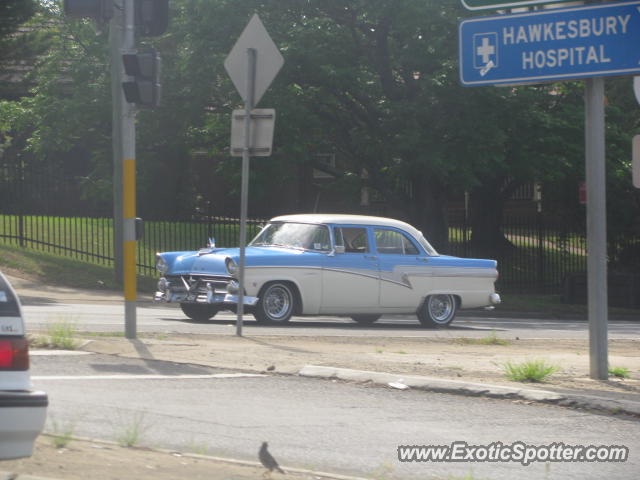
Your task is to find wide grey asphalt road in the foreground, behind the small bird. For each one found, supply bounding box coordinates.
[32,354,640,480]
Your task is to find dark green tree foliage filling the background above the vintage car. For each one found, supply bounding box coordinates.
[0,0,640,247]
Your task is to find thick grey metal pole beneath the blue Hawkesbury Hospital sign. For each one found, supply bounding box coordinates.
[585,77,609,380]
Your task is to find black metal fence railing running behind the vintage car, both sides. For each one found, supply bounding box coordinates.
[0,214,640,294]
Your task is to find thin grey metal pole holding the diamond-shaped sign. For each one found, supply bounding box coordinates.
[236,48,257,337]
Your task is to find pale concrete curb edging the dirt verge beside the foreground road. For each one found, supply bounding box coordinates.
[298,365,640,415]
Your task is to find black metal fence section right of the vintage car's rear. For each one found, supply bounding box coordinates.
[446,212,640,306]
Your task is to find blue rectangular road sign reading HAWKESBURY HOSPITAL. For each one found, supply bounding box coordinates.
[459,0,640,86]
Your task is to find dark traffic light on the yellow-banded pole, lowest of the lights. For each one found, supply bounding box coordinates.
[122,50,161,108]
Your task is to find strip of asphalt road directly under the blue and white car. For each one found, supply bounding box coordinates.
[24,303,640,339]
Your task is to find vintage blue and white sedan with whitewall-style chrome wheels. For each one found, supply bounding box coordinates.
[155,214,500,327]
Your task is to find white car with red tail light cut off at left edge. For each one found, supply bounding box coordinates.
[0,272,49,460]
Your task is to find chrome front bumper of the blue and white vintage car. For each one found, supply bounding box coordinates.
[153,277,258,306]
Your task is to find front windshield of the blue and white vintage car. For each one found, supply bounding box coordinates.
[249,222,331,252]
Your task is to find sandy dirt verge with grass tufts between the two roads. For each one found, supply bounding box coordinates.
[84,335,640,400]
